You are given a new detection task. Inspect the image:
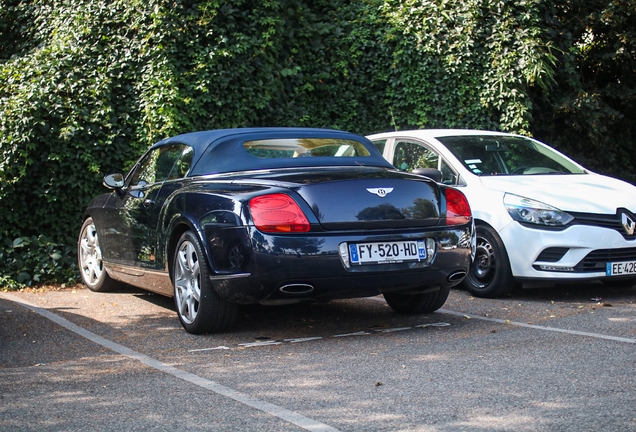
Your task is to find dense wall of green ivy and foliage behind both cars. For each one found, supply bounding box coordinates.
[0,0,636,284]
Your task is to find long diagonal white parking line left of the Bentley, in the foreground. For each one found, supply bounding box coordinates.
[0,293,339,432]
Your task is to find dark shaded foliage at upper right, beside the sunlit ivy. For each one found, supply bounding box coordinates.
[532,0,636,183]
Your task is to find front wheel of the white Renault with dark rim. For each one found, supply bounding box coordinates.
[461,225,519,298]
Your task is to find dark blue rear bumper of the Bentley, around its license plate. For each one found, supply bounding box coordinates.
[211,226,473,303]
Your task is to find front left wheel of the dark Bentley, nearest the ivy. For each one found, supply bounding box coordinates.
[77,218,121,292]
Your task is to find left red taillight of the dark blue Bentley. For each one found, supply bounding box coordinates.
[250,194,310,232]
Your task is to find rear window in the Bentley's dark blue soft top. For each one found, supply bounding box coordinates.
[243,138,371,159]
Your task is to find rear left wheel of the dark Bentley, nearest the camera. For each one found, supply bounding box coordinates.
[173,231,238,334]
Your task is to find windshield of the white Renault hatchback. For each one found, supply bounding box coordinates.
[437,135,585,176]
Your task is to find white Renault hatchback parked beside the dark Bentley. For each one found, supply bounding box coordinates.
[368,129,636,297]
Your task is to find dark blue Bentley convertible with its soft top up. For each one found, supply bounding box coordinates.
[78,128,475,333]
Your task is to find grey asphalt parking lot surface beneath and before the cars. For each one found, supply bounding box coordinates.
[0,283,636,431]
